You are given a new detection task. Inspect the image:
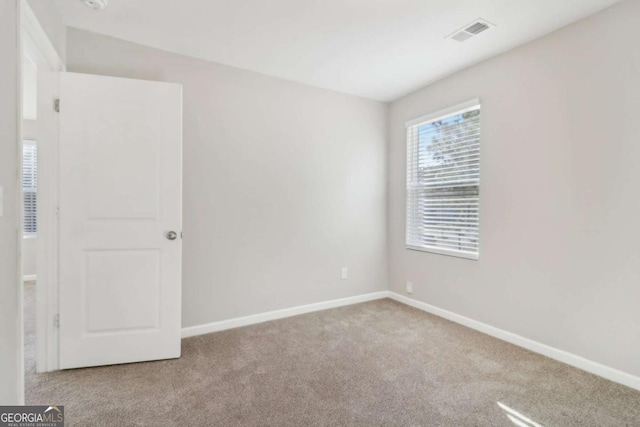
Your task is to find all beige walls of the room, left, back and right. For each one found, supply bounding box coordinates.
[0,0,640,403]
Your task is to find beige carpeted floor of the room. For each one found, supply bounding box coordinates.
[26,284,640,427]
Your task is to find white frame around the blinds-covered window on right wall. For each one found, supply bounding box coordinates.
[405,98,481,260]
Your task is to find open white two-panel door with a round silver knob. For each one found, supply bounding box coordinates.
[59,73,182,369]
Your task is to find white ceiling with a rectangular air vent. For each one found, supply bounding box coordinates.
[56,0,619,101]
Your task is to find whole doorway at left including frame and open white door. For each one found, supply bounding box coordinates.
[20,1,182,403]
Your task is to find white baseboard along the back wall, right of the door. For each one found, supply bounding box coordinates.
[182,291,389,338]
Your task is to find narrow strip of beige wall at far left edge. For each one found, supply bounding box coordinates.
[0,0,22,405]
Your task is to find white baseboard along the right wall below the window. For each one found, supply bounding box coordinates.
[388,292,640,390]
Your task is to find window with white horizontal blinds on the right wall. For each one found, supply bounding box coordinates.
[406,100,480,259]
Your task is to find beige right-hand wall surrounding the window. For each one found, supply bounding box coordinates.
[389,1,640,375]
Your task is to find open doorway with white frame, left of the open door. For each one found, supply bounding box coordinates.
[18,0,65,390]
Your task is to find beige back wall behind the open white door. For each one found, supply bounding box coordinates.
[67,29,387,326]
